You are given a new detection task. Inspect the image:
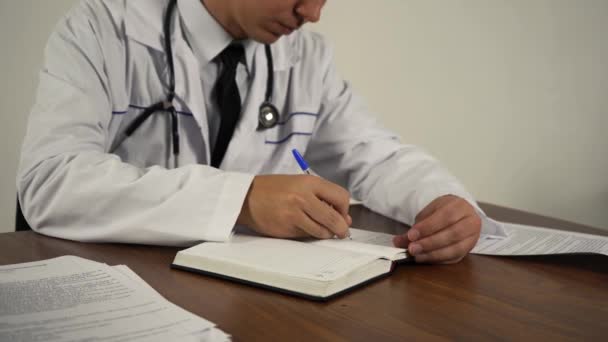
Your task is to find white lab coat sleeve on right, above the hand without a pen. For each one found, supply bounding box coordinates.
[306,35,504,236]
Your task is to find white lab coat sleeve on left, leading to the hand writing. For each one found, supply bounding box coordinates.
[17,3,253,245]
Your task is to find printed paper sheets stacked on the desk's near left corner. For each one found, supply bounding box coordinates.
[0,256,230,341]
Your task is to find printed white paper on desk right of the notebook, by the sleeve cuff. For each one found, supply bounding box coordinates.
[471,223,608,255]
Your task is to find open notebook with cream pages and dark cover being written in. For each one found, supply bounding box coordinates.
[172,228,407,300]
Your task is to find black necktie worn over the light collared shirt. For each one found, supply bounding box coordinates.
[211,45,244,167]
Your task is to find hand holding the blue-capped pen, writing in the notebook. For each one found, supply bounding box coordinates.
[237,175,352,239]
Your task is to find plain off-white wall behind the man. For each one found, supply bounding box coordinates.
[0,0,608,231]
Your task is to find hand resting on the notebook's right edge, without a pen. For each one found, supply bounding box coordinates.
[393,195,481,264]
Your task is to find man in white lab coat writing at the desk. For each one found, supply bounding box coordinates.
[17,0,499,263]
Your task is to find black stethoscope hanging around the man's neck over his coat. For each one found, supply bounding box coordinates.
[110,0,279,165]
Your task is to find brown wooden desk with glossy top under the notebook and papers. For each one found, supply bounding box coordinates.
[0,204,608,341]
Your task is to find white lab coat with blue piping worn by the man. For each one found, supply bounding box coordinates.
[17,0,504,245]
